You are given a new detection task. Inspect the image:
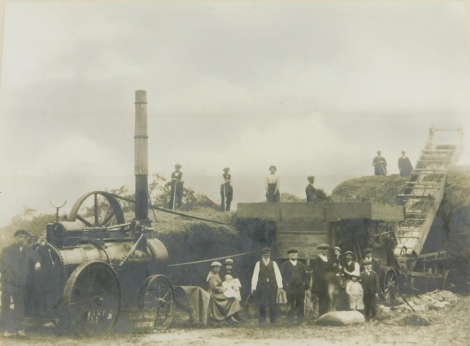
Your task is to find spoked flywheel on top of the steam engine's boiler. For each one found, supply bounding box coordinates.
[68,191,125,227]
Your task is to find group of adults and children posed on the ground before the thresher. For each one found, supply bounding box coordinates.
[202,244,381,325]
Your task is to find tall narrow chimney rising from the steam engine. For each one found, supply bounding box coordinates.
[134,90,151,224]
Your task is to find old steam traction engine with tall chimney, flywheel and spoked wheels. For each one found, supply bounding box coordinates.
[27,91,175,336]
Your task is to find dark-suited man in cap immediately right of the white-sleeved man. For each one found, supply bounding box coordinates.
[281,249,309,323]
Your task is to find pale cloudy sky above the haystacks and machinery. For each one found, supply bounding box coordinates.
[0,2,470,226]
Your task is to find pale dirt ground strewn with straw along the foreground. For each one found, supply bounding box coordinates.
[0,296,470,346]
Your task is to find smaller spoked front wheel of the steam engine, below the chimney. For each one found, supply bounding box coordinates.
[137,275,175,328]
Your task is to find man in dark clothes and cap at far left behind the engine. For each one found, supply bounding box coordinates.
[0,229,41,337]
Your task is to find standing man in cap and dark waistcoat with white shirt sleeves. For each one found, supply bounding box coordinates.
[250,247,283,325]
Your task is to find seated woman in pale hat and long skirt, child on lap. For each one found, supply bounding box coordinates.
[206,261,241,323]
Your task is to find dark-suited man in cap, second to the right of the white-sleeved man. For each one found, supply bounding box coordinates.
[310,243,335,316]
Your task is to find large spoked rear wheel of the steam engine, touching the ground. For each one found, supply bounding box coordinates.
[64,262,121,336]
